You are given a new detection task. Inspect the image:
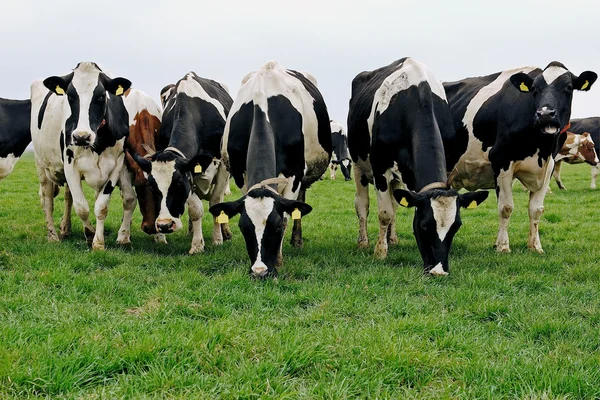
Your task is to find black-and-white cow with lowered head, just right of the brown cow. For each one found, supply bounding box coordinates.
[134,72,233,254]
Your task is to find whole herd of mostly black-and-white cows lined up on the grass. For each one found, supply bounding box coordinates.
[0,58,600,277]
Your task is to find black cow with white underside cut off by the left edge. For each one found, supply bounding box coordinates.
[0,98,31,180]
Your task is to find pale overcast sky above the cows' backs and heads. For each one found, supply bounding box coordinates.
[0,0,600,126]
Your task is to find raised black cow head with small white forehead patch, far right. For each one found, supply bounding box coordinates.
[510,61,598,134]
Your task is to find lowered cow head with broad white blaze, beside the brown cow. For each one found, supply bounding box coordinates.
[133,148,217,233]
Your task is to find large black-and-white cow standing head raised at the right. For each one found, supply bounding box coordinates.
[444,62,597,253]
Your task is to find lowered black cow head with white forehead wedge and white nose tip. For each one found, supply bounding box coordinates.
[394,189,488,275]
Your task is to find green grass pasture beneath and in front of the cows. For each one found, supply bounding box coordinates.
[0,154,600,399]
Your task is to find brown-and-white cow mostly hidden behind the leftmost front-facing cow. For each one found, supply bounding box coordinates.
[123,89,166,243]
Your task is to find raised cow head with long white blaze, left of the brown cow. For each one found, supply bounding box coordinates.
[44,62,131,147]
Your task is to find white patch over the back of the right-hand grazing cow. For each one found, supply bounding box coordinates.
[367,58,448,136]
